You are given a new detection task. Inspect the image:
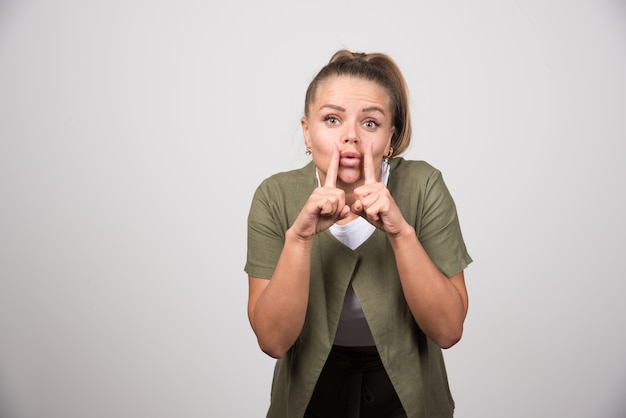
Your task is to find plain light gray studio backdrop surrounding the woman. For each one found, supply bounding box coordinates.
[0,0,626,418]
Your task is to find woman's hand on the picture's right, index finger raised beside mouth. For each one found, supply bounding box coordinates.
[352,142,408,236]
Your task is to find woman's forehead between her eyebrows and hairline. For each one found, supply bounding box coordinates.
[313,76,390,108]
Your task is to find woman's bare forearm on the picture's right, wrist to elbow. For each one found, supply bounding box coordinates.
[389,226,467,348]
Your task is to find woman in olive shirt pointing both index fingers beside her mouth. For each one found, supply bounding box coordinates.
[245,50,472,418]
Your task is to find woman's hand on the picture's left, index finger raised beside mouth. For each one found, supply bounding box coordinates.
[291,145,350,240]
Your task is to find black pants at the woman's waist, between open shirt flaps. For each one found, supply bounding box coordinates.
[304,351,406,418]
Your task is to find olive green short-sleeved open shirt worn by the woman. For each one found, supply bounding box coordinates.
[245,158,472,418]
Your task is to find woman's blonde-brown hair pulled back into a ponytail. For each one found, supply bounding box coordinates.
[304,49,411,156]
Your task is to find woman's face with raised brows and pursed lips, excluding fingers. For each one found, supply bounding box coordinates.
[302,76,394,189]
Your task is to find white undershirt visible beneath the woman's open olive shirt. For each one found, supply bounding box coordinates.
[316,161,389,347]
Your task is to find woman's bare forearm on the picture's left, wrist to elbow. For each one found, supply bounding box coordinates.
[252,230,313,358]
